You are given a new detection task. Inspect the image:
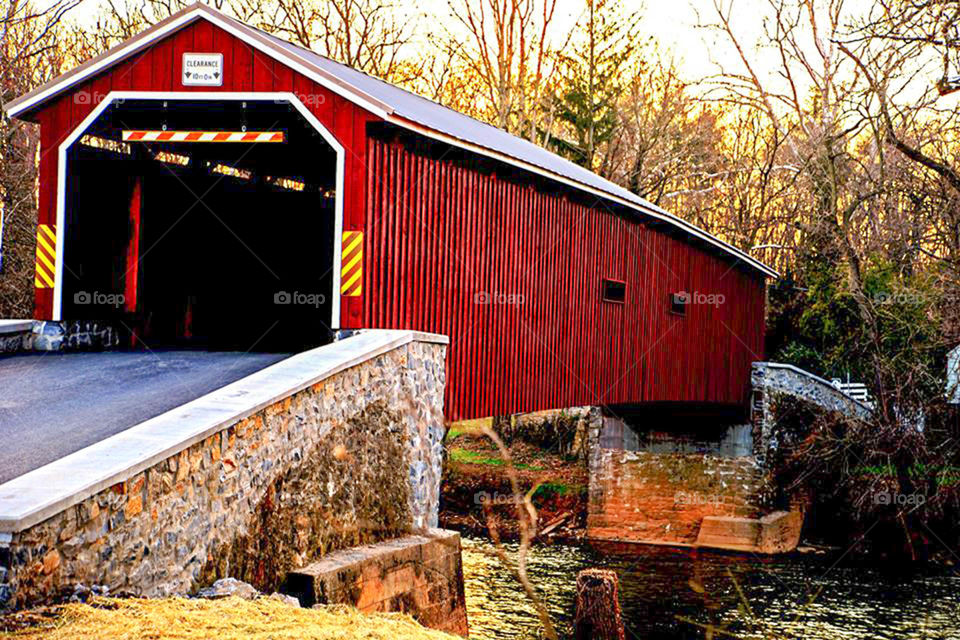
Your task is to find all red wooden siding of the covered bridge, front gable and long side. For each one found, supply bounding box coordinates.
[24,15,765,419]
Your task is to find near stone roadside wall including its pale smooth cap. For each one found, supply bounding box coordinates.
[0,331,465,631]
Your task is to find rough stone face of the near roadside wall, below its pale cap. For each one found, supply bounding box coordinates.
[0,339,446,607]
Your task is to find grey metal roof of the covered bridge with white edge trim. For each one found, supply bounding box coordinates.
[6,3,777,277]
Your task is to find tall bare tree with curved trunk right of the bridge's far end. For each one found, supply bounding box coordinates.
[696,0,936,421]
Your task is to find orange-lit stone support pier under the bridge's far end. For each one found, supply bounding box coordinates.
[587,414,770,546]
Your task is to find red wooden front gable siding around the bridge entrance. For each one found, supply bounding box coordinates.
[35,20,379,328]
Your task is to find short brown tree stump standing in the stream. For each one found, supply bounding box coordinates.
[573,569,624,640]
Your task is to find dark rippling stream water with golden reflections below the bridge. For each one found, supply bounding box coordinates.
[463,539,960,640]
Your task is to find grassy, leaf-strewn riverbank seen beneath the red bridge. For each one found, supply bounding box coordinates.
[440,420,588,543]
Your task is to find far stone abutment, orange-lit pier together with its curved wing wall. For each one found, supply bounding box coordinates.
[587,362,871,553]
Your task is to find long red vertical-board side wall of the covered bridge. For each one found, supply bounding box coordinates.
[363,137,764,419]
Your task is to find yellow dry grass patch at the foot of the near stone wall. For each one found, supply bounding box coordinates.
[0,598,456,640]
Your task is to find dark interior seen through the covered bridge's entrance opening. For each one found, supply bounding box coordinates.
[62,101,336,351]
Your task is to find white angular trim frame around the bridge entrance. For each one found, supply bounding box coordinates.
[53,91,346,330]
